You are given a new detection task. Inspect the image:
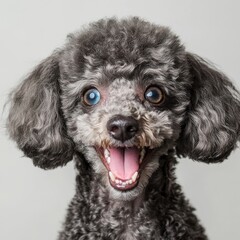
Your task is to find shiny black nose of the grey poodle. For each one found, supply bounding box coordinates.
[107,115,139,142]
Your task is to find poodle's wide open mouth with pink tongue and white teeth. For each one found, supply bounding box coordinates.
[98,147,147,191]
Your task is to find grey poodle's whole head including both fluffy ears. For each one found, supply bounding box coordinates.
[8,18,240,200]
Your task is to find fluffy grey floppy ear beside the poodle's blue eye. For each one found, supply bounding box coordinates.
[7,52,73,169]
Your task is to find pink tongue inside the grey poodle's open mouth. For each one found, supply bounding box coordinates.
[109,147,140,180]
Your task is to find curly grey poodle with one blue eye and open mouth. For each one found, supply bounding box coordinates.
[7,17,240,240]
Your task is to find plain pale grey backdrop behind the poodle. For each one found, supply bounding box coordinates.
[0,0,240,240]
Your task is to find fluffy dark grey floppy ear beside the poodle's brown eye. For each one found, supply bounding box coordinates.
[177,53,240,163]
